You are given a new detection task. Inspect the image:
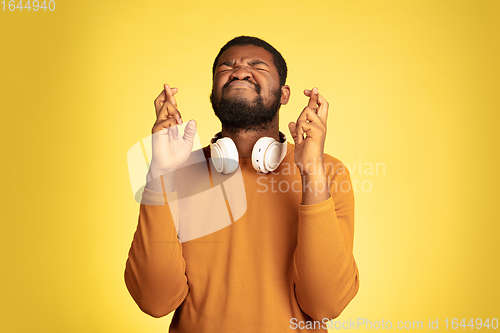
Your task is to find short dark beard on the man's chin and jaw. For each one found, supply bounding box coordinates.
[210,82,281,133]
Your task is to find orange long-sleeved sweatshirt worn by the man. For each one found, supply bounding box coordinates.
[125,143,359,333]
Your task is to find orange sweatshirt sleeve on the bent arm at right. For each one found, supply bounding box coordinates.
[294,160,359,320]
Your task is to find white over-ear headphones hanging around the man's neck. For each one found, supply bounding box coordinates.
[210,132,287,174]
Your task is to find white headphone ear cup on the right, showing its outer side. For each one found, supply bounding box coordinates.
[252,137,281,173]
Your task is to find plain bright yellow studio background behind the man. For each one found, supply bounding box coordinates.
[0,0,500,332]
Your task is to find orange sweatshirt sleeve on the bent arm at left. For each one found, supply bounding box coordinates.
[125,189,189,317]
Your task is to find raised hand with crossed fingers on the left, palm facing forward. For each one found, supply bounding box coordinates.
[148,84,196,179]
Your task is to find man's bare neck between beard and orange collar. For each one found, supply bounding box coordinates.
[221,117,280,158]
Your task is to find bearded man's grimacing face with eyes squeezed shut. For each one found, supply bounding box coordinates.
[210,45,282,130]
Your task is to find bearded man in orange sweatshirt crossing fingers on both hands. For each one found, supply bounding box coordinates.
[125,36,358,332]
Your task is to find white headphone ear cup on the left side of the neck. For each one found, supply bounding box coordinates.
[210,138,239,175]
